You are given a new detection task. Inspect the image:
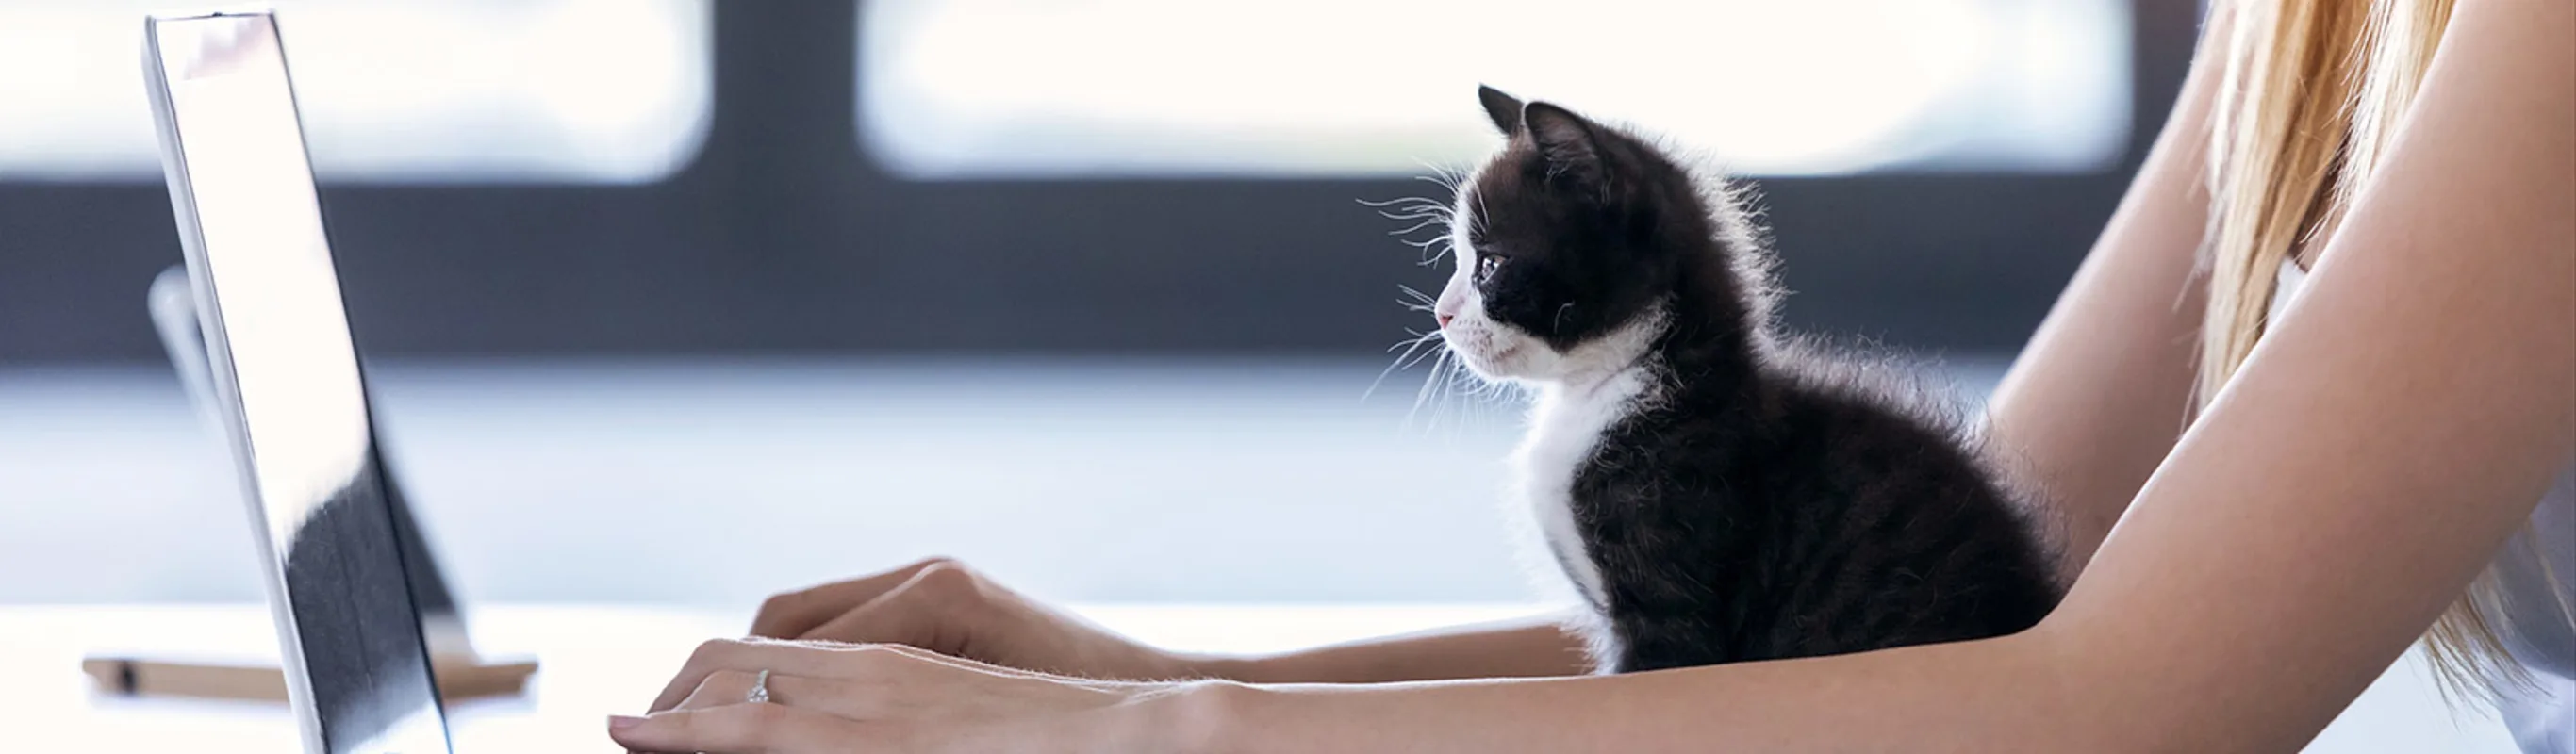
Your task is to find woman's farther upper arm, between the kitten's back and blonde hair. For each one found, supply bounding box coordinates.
[1986,13,2228,571]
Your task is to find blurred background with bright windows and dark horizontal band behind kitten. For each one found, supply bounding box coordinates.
[0,0,2514,746]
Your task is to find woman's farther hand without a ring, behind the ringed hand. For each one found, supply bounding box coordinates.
[752,558,1208,680]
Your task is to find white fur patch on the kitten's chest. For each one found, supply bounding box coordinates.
[1512,373,1646,605]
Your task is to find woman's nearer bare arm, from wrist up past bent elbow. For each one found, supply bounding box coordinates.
[1196,0,2576,751]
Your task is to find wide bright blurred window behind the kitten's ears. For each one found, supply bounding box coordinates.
[858,0,2130,177]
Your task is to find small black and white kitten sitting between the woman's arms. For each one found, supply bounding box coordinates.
[1432,88,2058,672]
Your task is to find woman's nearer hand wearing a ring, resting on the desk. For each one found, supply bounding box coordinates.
[608,638,1206,754]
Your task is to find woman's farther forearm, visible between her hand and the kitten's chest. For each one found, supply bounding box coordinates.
[1193,617,1592,684]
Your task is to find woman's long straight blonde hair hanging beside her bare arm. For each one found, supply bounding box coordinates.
[2197,0,2576,700]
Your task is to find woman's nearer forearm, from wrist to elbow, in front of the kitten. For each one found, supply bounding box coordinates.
[1169,633,2102,751]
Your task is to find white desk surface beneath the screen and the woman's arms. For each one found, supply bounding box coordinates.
[0,605,2514,754]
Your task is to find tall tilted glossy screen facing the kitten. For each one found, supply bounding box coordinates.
[144,13,451,754]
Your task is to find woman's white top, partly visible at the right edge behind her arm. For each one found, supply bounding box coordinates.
[2272,262,2576,754]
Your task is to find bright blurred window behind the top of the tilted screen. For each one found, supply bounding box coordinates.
[0,0,711,183]
